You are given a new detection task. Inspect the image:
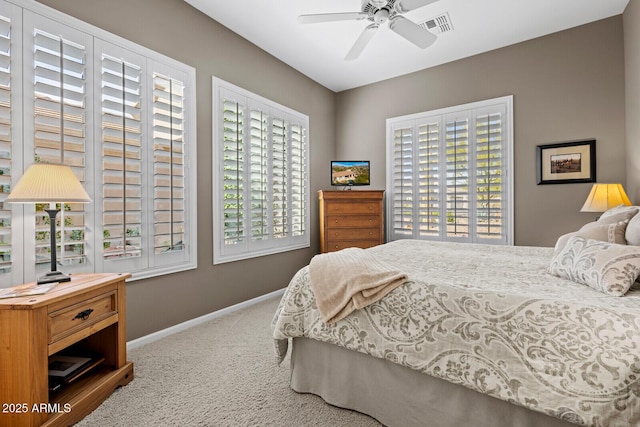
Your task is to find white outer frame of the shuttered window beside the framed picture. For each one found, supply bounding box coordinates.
[386,95,515,245]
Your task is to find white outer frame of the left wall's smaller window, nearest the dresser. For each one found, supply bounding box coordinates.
[212,77,310,264]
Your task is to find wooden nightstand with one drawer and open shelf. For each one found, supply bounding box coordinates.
[0,274,133,426]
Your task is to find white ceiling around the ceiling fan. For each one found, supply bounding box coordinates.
[185,0,629,92]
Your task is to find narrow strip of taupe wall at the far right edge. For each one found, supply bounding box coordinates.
[623,0,640,205]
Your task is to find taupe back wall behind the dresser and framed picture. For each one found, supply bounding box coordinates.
[336,15,628,246]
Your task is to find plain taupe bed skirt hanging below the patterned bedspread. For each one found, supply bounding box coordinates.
[291,338,576,427]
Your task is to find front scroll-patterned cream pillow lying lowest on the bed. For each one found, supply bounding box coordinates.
[549,236,640,296]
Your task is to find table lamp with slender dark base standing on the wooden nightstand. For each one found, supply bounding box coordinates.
[7,163,91,285]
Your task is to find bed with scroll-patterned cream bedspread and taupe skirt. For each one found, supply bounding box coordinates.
[272,221,640,427]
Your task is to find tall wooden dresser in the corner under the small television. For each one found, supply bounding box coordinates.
[318,190,384,253]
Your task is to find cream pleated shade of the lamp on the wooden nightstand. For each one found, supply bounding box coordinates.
[7,163,91,203]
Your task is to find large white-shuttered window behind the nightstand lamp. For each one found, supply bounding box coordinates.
[0,0,196,287]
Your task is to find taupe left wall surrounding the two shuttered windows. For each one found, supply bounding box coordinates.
[41,0,335,340]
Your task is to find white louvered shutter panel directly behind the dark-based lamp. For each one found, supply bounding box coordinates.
[23,12,92,278]
